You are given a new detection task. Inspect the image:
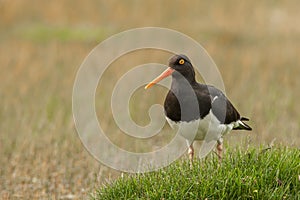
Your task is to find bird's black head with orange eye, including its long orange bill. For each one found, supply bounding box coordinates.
[145,54,195,89]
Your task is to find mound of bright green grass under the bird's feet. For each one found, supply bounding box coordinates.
[91,147,300,199]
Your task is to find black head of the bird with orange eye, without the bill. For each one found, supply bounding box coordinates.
[169,54,195,82]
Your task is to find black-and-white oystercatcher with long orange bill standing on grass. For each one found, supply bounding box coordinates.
[145,54,252,166]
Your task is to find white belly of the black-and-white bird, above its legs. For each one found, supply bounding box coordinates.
[166,112,233,141]
